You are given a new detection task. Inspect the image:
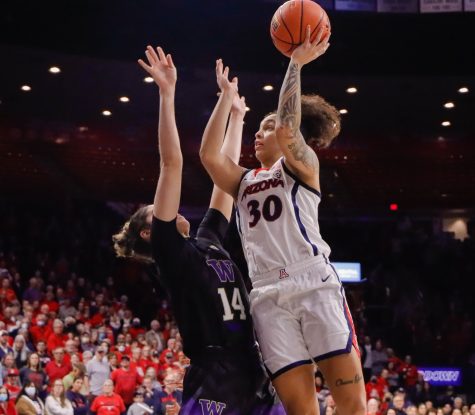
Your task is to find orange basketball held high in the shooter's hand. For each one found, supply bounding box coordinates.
[270,0,330,57]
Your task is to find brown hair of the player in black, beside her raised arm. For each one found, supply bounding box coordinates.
[112,206,153,263]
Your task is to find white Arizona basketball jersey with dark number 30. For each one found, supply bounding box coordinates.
[236,158,330,281]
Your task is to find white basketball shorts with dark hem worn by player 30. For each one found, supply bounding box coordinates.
[250,255,359,379]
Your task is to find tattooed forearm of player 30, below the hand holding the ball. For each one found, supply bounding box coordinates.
[277,62,301,137]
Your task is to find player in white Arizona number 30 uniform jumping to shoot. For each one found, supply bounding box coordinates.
[200,28,366,415]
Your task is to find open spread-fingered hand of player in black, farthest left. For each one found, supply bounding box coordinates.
[138,46,177,94]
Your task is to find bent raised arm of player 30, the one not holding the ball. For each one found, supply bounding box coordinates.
[200,59,244,198]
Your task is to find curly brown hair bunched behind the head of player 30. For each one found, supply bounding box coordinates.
[300,94,341,148]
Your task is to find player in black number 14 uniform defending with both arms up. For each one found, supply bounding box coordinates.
[114,46,284,415]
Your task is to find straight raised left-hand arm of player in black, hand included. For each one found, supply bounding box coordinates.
[138,46,183,222]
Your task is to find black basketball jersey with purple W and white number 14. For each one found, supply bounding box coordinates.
[151,209,255,360]
